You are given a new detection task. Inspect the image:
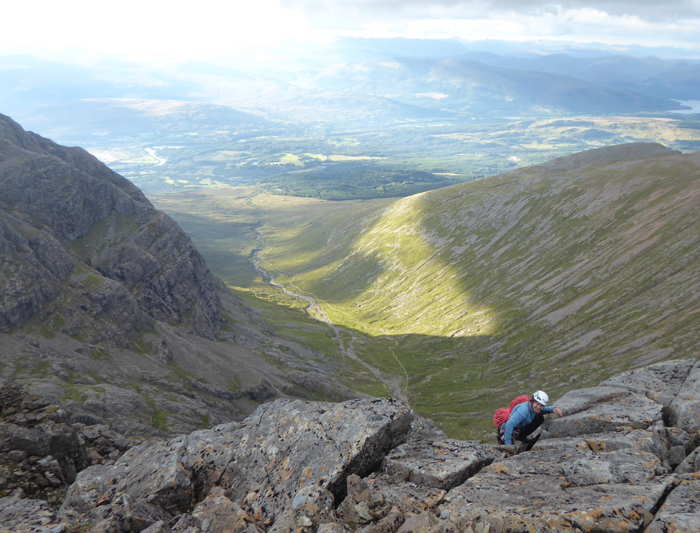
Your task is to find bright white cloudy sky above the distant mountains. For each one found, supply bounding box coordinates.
[0,0,700,61]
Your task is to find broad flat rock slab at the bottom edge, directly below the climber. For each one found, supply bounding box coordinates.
[440,442,673,532]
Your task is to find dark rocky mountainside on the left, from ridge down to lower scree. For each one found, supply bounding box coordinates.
[0,111,366,436]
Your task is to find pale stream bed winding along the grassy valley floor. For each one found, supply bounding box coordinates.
[252,228,410,405]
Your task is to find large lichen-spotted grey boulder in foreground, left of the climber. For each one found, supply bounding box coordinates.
[59,400,413,532]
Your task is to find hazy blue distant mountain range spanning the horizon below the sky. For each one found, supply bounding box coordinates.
[0,40,700,135]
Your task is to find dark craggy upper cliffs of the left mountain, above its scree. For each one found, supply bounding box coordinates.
[0,115,221,344]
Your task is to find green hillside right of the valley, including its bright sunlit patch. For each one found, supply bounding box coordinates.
[150,143,700,439]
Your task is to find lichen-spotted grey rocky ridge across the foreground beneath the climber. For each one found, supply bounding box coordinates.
[0,360,700,533]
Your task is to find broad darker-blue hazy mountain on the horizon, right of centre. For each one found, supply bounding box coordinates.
[310,58,677,116]
